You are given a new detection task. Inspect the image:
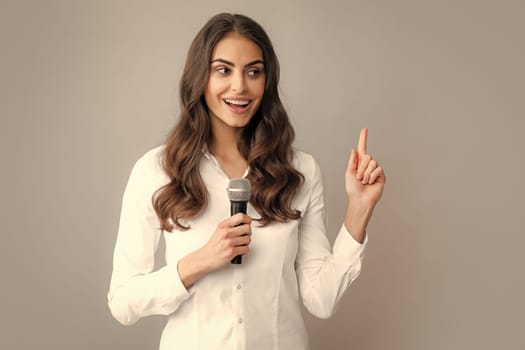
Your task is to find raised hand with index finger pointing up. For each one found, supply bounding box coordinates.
[345,128,386,208]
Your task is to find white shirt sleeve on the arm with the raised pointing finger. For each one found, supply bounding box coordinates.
[296,158,368,318]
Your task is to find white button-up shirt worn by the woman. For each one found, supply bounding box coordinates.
[108,146,367,350]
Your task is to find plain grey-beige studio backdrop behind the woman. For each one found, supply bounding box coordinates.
[0,0,525,350]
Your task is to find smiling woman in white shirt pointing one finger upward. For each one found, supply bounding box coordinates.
[108,14,385,350]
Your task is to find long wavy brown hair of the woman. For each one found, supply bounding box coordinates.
[152,13,304,232]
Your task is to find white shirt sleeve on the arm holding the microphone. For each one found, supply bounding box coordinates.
[107,152,192,325]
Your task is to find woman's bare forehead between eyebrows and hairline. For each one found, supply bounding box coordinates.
[211,32,263,64]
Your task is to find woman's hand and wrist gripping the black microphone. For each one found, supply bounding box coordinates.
[177,213,252,288]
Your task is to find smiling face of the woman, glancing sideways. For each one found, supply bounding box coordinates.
[204,33,266,130]
